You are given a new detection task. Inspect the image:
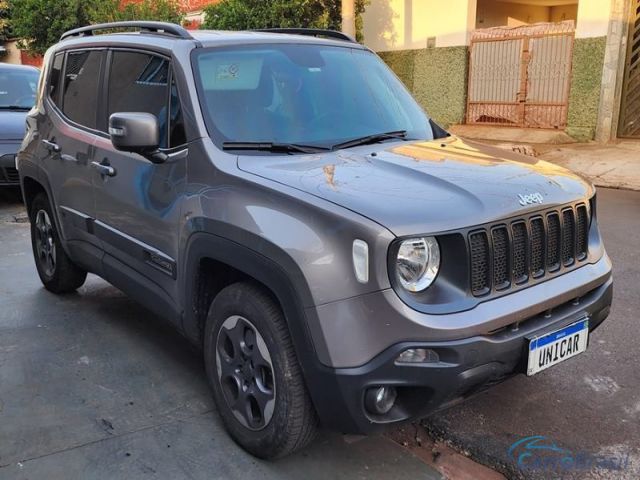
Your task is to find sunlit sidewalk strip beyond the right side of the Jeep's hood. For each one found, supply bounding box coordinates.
[533,140,640,191]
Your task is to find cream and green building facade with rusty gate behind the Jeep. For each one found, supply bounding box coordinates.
[358,0,640,141]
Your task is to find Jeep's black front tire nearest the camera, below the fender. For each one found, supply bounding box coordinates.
[204,282,318,459]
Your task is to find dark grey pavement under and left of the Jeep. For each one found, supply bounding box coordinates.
[0,186,441,480]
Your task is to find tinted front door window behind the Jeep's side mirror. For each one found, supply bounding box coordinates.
[107,51,171,147]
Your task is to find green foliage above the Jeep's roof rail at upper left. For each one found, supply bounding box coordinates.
[10,0,182,55]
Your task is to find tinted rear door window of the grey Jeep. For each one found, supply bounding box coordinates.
[62,50,102,129]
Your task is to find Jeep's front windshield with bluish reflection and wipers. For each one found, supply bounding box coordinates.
[194,44,433,148]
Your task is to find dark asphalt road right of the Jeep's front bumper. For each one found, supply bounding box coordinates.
[424,189,640,480]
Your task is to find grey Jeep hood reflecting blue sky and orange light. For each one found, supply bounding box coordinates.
[238,137,593,236]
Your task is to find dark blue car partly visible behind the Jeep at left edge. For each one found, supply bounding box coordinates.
[0,63,40,187]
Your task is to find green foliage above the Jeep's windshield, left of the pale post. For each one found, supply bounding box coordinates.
[202,0,342,30]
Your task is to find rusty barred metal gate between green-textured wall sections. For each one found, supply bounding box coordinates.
[466,21,576,129]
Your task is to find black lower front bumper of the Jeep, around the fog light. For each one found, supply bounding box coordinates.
[310,274,613,434]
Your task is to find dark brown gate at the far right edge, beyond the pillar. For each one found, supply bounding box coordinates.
[618,0,640,138]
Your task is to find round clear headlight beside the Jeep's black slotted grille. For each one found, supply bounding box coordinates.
[396,237,440,292]
